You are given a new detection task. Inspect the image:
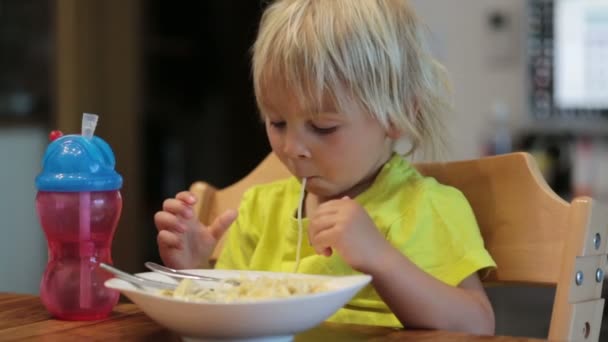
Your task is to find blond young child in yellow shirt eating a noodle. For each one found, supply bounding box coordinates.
[155,0,495,334]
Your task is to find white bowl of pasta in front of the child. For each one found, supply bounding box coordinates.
[105,269,371,341]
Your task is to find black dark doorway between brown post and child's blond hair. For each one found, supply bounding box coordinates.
[142,0,269,260]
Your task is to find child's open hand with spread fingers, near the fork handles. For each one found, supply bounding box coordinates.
[154,191,237,269]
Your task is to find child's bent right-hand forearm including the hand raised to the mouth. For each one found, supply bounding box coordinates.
[308,198,494,334]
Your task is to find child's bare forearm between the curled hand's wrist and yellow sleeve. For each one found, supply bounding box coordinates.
[369,244,494,335]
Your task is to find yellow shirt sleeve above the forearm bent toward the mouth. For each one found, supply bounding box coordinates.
[388,183,496,286]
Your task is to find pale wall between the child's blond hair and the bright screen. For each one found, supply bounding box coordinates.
[412,0,527,159]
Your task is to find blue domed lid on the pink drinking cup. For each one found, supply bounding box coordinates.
[36,134,122,192]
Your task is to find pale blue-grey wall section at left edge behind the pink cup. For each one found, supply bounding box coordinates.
[0,127,47,293]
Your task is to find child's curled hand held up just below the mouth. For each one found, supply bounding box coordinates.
[308,197,390,273]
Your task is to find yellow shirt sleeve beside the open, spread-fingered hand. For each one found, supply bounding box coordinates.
[215,190,258,270]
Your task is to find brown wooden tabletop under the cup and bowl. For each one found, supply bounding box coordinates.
[0,293,539,342]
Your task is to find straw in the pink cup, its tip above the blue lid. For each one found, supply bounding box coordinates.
[79,113,98,308]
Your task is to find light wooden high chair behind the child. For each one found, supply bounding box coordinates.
[190,152,608,341]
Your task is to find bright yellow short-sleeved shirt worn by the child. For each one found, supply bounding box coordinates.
[216,155,496,327]
